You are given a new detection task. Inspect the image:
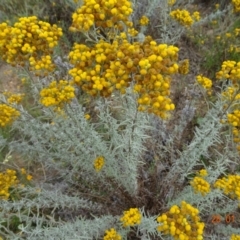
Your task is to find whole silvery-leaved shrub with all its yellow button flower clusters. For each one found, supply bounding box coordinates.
[0,0,240,240]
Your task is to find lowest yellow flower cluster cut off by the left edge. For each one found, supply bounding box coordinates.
[0,169,18,200]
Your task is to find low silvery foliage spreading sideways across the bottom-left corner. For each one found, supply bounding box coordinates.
[0,187,104,239]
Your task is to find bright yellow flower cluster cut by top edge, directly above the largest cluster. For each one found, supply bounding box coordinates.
[70,0,133,31]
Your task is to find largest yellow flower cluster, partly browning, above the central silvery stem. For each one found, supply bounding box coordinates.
[69,34,179,118]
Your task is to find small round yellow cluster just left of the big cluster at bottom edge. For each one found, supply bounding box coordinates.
[120,208,142,227]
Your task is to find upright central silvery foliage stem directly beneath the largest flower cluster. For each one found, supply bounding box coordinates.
[94,90,152,194]
